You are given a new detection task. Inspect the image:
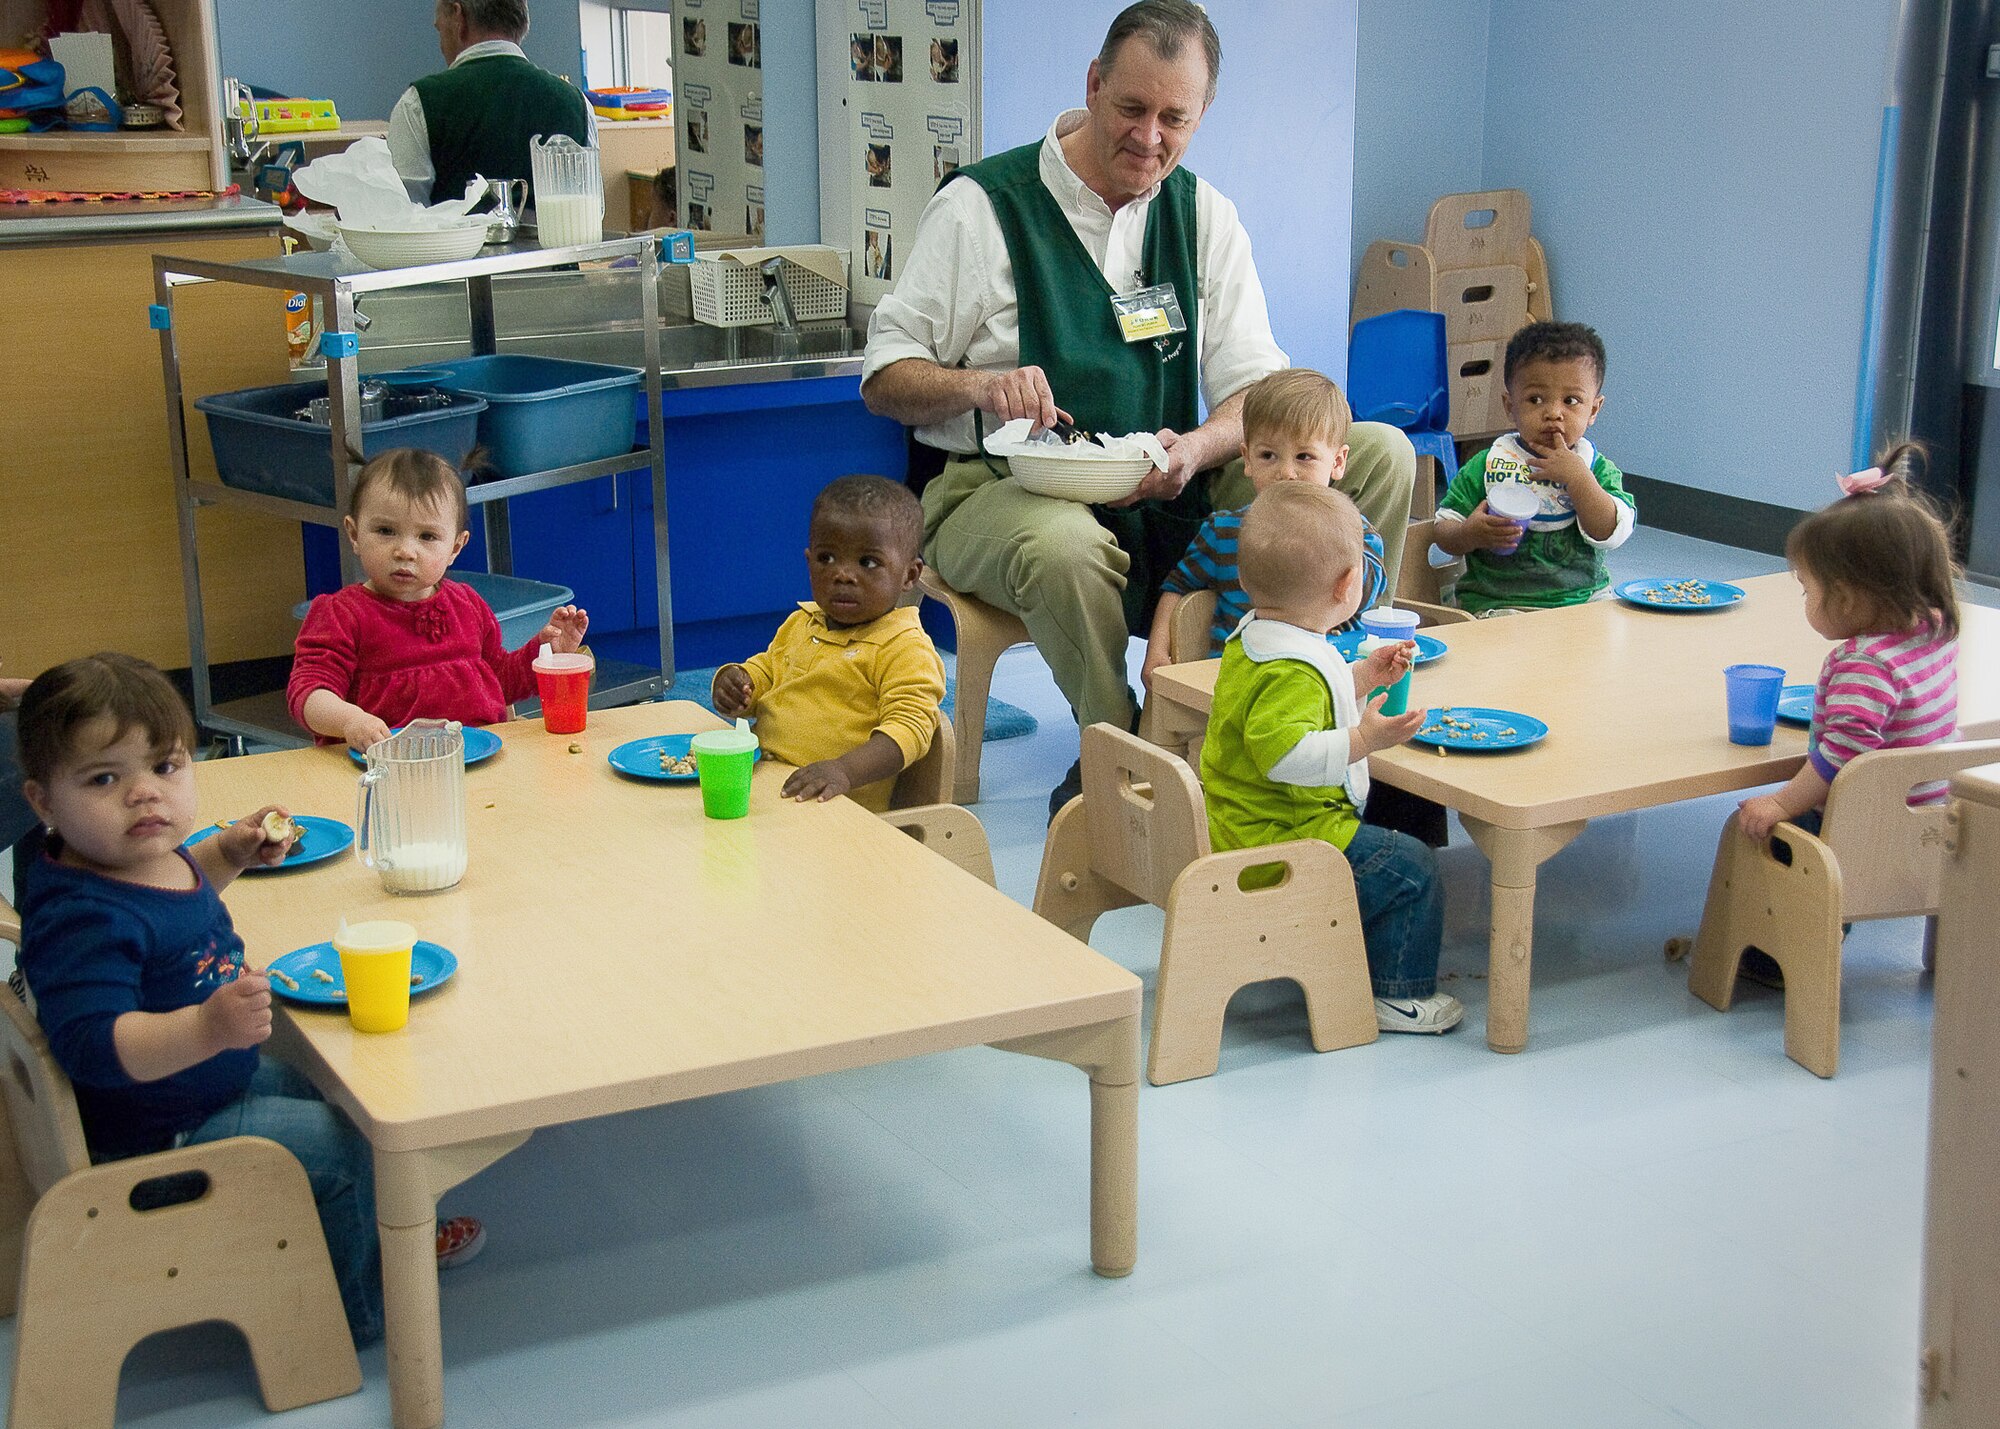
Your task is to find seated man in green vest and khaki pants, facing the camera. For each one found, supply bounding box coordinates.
[862,0,1416,817]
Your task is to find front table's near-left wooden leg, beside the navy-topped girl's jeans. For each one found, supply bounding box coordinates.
[376,1131,528,1429]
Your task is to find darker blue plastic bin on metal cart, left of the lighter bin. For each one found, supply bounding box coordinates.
[194,382,486,506]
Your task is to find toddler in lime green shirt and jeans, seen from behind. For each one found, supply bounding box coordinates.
[1202,482,1466,1033]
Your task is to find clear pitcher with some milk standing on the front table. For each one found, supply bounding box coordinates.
[354,719,466,893]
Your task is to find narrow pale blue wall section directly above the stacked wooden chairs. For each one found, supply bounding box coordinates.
[1350,0,1490,274]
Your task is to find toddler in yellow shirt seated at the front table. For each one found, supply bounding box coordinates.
[710,476,944,813]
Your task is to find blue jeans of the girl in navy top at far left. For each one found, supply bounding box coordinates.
[182,1057,382,1345]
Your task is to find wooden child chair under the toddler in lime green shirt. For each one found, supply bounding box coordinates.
[1034,725,1378,1087]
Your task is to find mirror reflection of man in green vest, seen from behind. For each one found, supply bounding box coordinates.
[388,0,598,204]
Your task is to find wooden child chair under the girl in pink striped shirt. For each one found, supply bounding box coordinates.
[1666,739,2000,1077]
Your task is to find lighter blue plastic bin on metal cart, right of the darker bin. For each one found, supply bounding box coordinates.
[438,354,644,476]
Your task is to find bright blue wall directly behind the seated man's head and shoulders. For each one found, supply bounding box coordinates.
[984,0,1358,378]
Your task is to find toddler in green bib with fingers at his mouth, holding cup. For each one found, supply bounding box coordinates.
[1434,322,1636,616]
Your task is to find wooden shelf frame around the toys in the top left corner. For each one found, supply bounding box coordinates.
[0,0,230,192]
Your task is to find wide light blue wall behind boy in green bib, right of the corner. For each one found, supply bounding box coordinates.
[1496,0,1894,508]
